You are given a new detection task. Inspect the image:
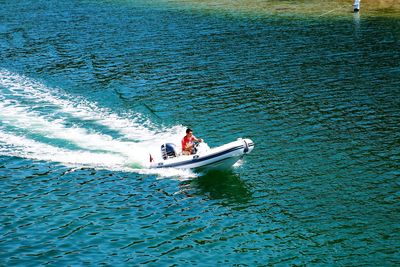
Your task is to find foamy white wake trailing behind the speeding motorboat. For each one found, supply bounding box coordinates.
[0,69,194,179]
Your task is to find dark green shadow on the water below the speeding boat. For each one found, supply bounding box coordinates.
[189,170,252,205]
